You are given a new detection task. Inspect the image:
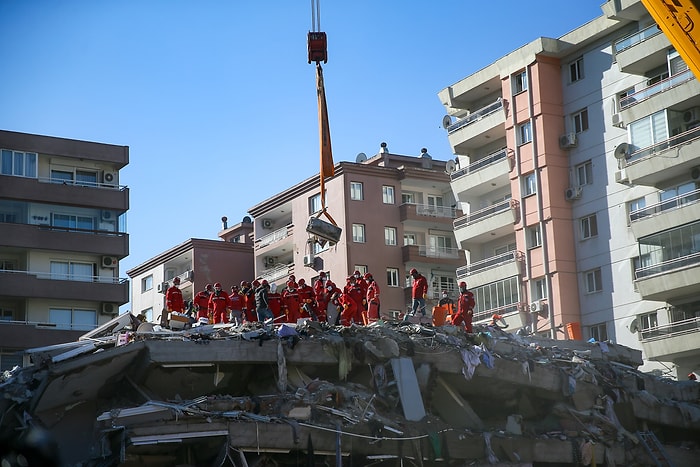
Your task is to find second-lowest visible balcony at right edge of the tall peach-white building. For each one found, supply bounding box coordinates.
[635,252,700,302]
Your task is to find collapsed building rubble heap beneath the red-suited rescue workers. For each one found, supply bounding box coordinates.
[0,313,700,466]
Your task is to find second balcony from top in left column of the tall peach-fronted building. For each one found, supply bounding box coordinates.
[450,148,513,199]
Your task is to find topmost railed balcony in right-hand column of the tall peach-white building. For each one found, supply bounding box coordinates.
[613,23,671,75]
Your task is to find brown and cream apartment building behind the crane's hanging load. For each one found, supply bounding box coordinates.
[248,143,464,317]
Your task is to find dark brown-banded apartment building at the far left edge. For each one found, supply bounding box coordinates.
[0,131,129,370]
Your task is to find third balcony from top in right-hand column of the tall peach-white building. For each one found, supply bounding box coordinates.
[625,127,700,186]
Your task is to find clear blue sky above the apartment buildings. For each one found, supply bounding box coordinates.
[0,0,602,286]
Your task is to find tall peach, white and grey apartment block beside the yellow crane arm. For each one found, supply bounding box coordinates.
[439,0,700,379]
